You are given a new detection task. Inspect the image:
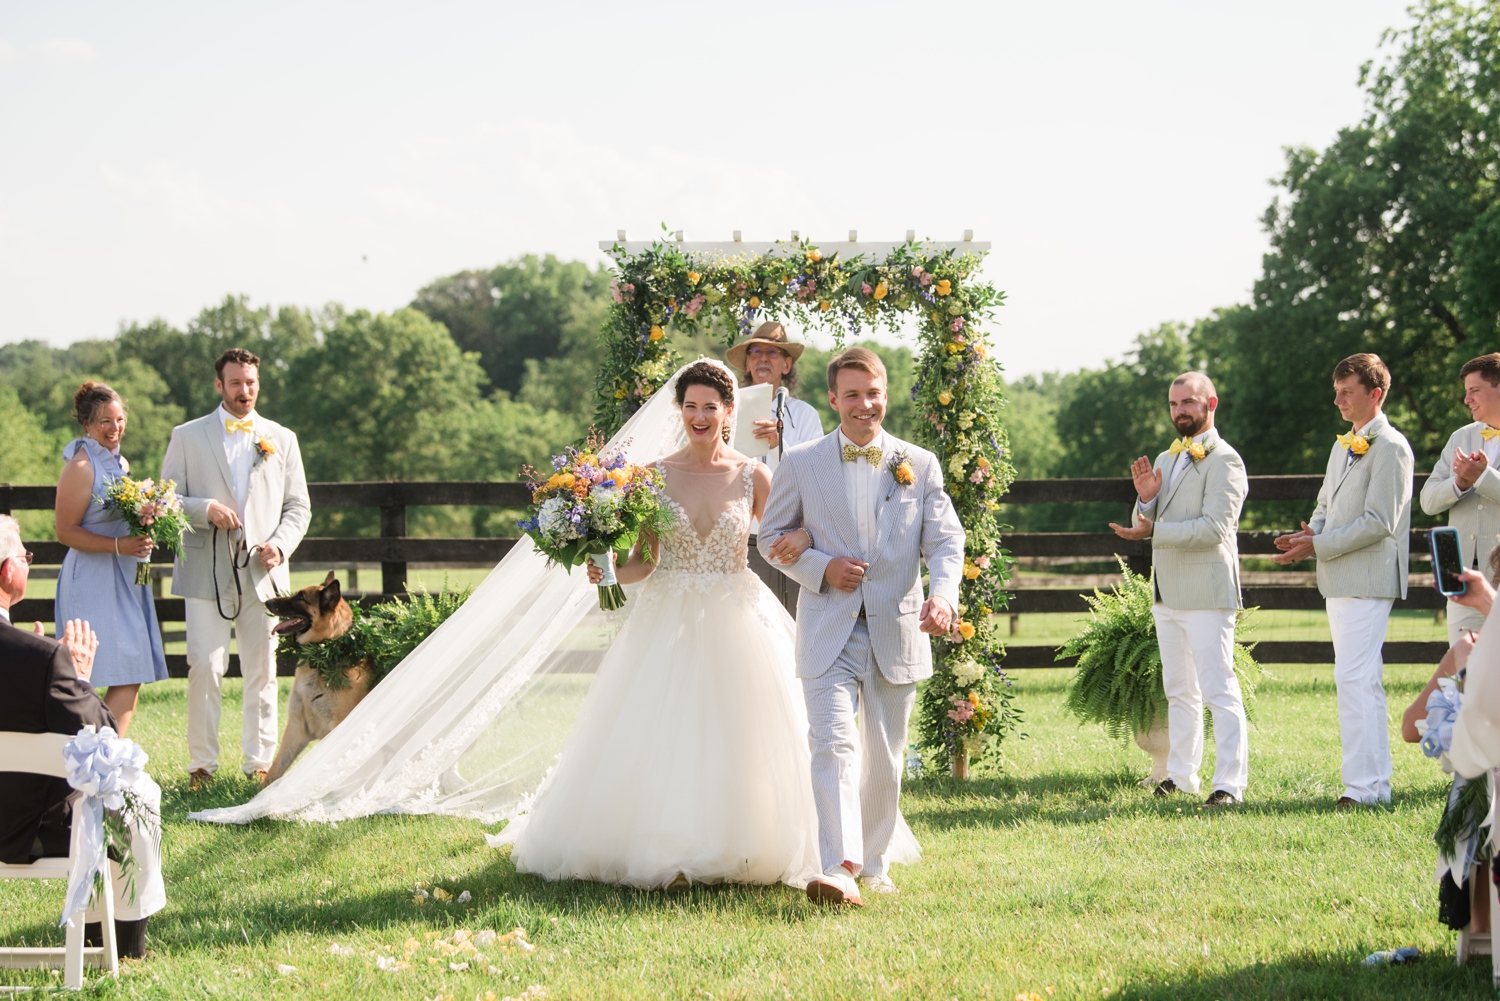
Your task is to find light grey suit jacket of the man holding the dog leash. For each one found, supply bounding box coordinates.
[162,411,312,602]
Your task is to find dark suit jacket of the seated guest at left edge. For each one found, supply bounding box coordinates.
[0,618,116,864]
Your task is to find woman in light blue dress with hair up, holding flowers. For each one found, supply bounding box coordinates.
[53,381,167,737]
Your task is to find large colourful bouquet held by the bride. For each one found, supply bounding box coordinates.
[518,435,671,609]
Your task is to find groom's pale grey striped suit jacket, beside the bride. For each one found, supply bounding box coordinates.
[759,431,965,684]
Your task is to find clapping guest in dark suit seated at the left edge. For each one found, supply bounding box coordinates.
[0,515,162,957]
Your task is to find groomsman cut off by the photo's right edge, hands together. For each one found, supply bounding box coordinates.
[1422,353,1500,645]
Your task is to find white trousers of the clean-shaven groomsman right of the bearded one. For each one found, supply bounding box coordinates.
[1328,597,1394,803]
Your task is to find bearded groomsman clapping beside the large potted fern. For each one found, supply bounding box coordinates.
[1110,372,1250,806]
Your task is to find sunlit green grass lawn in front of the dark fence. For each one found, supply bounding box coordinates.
[0,666,1493,1001]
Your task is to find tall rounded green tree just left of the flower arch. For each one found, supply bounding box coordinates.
[411,254,609,396]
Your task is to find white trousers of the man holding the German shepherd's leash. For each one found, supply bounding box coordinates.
[185,593,278,774]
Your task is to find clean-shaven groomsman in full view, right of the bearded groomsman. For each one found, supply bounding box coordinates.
[1274,354,1413,810]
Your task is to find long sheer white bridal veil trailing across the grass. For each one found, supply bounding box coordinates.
[189,369,728,824]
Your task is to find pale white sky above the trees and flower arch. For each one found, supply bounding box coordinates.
[0,0,1407,375]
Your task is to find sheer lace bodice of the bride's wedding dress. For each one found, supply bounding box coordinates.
[653,461,755,593]
